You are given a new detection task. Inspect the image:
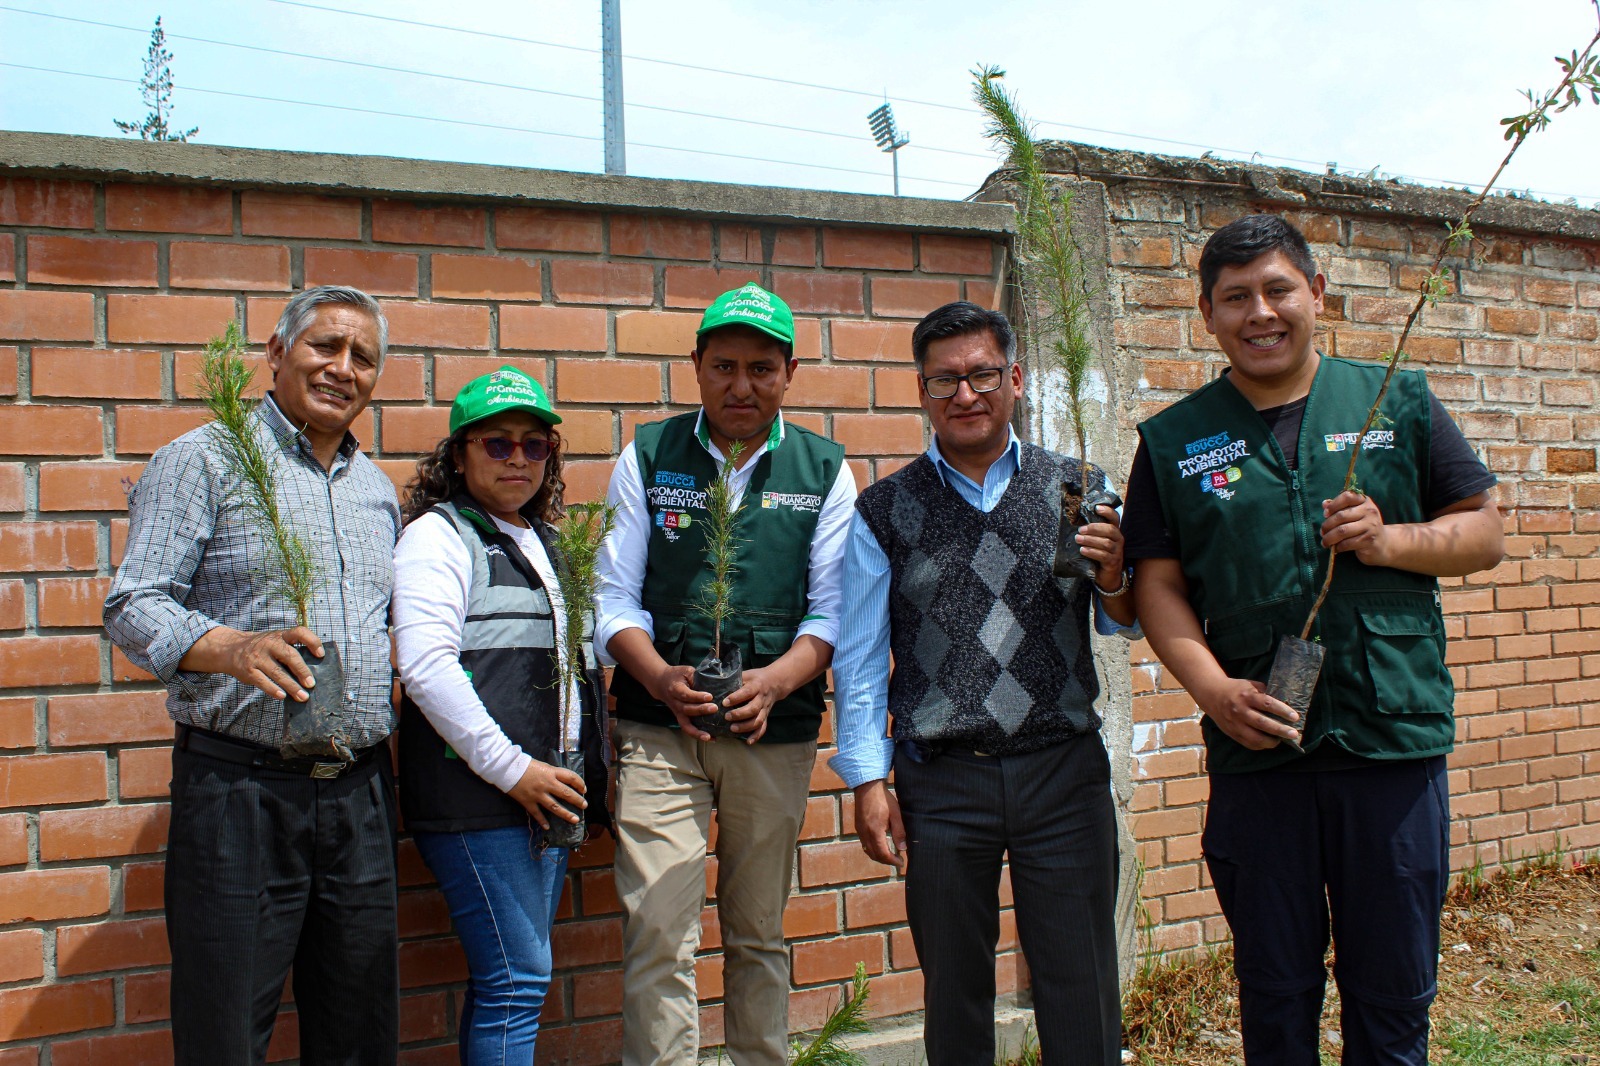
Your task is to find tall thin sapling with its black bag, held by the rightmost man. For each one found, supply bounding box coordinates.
[1267,30,1600,751]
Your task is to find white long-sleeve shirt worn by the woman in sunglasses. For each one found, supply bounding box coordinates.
[390,512,578,792]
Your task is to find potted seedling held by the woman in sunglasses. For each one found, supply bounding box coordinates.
[544,504,616,848]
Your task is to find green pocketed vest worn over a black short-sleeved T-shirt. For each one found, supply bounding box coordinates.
[1139,357,1454,773]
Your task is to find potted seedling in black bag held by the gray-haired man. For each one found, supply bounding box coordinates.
[202,322,355,762]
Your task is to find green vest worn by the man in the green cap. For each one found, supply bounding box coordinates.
[611,411,845,744]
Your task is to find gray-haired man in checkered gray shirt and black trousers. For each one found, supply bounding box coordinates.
[106,285,400,1066]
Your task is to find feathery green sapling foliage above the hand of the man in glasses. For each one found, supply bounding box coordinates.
[973,66,1096,459]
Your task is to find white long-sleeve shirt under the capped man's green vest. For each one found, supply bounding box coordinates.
[595,410,856,666]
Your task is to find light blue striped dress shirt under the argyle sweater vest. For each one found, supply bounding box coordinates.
[827,432,1141,787]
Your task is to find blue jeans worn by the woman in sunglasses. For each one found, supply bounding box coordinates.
[414,826,566,1066]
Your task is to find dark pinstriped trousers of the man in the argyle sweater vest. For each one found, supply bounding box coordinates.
[894,733,1122,1066]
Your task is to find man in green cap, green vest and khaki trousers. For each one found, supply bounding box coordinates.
[595,283,856,1066]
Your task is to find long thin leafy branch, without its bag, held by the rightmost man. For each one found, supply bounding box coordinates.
[1301,14,1600,640]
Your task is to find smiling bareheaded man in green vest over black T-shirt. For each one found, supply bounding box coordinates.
[1123,214,1501,1066]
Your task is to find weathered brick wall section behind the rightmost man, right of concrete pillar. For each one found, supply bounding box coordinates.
[1069,168,1600,949]
